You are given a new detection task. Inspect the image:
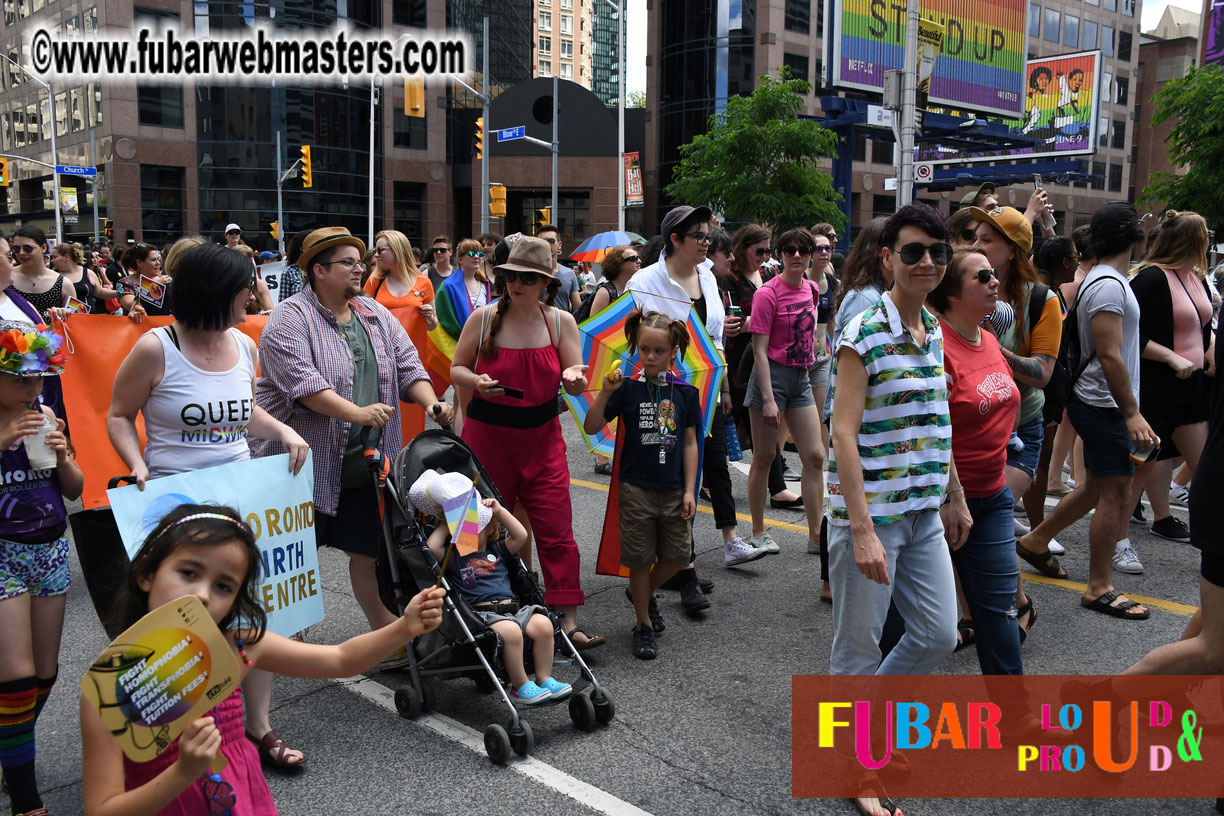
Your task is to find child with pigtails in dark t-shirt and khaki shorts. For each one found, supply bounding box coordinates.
[583,312,709,661]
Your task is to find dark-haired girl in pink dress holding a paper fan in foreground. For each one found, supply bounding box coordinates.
[81,504,446,816]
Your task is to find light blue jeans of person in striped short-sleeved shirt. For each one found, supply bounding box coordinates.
[829,510,956,674]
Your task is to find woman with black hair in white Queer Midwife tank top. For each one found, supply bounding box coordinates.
[106,239,310,767]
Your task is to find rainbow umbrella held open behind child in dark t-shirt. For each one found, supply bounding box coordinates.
[562,291,727,456]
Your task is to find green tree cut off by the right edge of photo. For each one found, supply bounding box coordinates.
[1142,65,1224,230]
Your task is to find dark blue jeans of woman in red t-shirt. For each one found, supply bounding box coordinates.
[952,484,1024,674]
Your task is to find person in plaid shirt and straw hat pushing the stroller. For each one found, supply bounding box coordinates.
[251,226,452,645]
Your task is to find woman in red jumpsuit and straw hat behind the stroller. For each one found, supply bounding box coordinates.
[450,237,603,650]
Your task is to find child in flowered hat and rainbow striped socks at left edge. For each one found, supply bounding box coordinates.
[0,321,84,816]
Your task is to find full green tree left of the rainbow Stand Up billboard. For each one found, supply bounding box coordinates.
[666,67,845,229]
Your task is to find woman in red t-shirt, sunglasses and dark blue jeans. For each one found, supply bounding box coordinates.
[927,250,1032,674]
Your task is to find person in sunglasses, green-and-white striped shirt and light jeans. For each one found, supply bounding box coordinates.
[827,203,972,674]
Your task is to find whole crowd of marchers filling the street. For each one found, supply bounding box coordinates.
[0,193,1224,816]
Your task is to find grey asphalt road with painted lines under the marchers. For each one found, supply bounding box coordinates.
[19,417,1214,816]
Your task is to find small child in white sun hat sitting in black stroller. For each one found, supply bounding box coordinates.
[409,470,573,705]
